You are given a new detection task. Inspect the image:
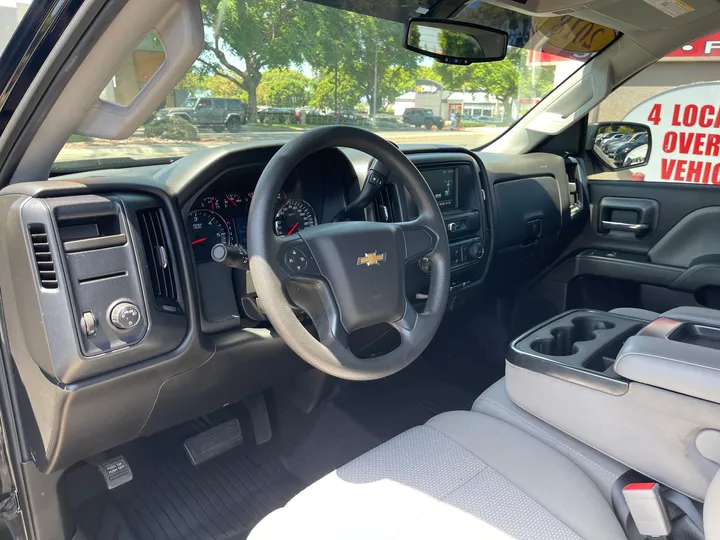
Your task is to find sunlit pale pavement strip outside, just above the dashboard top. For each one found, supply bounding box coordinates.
[58,128,504,161]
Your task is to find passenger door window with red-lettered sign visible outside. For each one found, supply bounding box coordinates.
[589,32,720,185]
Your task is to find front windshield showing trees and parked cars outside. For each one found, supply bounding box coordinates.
[6,0,617,170]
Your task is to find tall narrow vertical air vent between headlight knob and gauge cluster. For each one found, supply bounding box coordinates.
[137,208,179,313]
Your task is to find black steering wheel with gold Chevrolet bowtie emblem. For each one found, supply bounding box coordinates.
[247,126,450,380]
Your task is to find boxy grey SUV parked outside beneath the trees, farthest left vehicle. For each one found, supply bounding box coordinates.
[159,97,247,133]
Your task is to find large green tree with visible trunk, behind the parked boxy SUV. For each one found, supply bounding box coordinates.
[201,0,309,122]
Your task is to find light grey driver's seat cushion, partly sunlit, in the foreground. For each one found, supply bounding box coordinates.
[249,412,625,540]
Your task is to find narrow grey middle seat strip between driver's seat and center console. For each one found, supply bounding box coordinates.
[472,377,629,501]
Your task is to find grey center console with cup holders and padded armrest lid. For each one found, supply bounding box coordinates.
[506,308,720,500]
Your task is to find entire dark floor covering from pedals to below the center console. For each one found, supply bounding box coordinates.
[76,348,490,540]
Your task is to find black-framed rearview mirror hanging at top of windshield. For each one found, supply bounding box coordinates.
[405,19,508,65]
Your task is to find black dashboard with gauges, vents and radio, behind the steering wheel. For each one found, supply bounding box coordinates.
[0,143,580,472]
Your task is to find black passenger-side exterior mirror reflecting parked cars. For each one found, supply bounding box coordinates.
[585,122,652,171]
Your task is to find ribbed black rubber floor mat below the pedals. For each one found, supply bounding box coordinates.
[80,430,304,540]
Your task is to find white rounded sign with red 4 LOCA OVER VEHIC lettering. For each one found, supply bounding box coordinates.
[624,82,720,184]
